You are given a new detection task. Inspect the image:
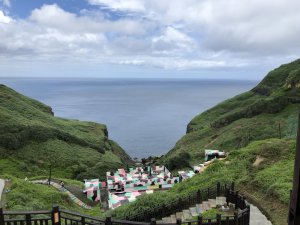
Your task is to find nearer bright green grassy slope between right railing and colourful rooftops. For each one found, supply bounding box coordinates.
[112,139,295,225]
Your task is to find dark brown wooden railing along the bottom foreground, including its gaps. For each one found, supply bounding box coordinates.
[0,184,250,225]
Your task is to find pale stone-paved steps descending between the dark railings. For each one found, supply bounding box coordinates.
[157,197,226,224]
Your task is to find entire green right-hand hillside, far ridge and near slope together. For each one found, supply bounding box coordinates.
[113,60,300,225]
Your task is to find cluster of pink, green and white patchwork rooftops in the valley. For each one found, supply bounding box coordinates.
[83,153,225,209]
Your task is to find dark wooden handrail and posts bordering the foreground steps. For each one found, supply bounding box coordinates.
[0,184,250,225]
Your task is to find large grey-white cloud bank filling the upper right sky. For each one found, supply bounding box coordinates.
[89,0,300,54]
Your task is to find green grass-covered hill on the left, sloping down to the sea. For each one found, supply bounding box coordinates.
[0,85,132,180]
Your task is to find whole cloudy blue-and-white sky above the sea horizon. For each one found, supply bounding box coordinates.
[0,0,300,79]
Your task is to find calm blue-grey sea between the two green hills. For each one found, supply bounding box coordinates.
[0,78,257,158]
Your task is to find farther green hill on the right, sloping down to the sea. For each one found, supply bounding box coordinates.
[161,60,300,169]
